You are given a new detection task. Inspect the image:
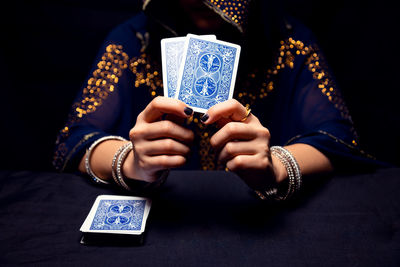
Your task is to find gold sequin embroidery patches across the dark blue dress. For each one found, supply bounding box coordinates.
[53,37,358,170]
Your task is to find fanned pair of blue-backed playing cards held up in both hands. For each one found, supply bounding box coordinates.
[161,34,240,113]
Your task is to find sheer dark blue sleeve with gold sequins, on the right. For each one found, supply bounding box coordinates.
[271,24,387,170]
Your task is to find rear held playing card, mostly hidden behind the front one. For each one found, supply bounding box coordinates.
[161,34,217,98]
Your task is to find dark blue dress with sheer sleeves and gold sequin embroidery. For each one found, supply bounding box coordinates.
[53,13,377,174]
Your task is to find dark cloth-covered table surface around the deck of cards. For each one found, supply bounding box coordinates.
[0,168,400,266]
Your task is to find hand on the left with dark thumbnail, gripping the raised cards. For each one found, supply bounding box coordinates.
[122,97,194,182]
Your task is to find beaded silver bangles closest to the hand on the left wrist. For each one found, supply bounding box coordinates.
[111,142,169,193]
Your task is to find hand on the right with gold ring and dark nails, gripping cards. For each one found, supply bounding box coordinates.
[202,99,287,190]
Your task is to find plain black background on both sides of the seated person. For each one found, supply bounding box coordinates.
[0,0,400,170]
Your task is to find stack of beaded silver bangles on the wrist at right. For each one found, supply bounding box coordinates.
[256,146,302,201]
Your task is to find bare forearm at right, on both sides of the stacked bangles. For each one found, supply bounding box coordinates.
[272,144,333,182]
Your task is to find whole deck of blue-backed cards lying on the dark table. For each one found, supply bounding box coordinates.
[80,195,151,245]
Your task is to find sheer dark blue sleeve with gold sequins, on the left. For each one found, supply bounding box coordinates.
[53,14,146,171]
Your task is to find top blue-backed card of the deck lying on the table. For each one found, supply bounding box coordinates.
[80,195,151,235]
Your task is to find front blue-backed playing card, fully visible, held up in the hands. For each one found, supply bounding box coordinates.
[175,34,240,113]
